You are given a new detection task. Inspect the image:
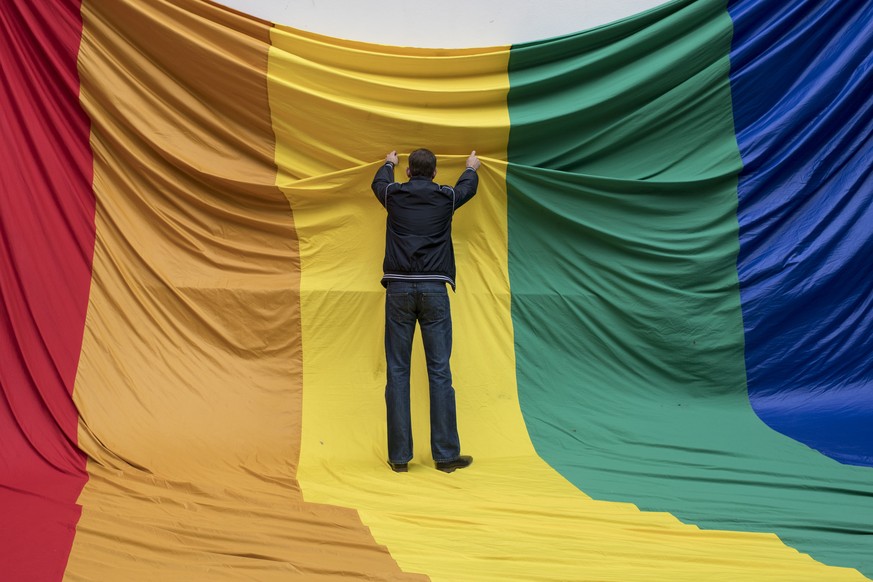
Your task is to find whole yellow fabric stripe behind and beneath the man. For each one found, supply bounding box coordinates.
[269,22,858,582]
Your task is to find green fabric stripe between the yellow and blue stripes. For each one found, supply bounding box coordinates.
[507,1,873,575]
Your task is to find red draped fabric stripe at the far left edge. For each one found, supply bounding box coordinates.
[0,0,94,582]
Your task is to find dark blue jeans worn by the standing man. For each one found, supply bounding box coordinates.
[385,281,461,463]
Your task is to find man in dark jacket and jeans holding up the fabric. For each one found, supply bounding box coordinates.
[373,149,479,473]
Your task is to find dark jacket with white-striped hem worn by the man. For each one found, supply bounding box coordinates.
[373,162,479,289]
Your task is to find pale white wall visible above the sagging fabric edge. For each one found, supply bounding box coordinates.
[211,0,664,48]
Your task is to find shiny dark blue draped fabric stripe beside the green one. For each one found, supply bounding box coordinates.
[729,0,873,466]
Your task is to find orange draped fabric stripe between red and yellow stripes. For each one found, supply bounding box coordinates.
[66,0,418,581]
